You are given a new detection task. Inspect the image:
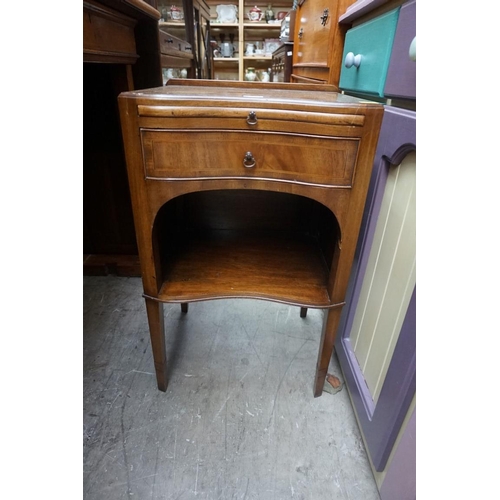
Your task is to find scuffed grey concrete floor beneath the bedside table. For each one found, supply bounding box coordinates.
[83,276,380,500]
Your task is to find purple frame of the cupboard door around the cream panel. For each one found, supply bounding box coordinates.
[336,106,416,471]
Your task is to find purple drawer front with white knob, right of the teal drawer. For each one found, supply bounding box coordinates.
[384,0,417,99]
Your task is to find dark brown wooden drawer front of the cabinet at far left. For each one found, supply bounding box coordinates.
[83,2,138,63]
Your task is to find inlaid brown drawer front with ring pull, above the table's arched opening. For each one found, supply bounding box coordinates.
[141,130,358,187]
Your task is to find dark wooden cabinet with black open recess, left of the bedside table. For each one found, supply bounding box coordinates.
[83,0,162,274]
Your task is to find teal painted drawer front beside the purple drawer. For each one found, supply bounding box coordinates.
[339,7,400,97]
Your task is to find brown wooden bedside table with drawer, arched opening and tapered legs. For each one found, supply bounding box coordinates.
[118,80,383,396]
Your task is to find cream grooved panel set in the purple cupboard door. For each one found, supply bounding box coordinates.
[351,153,416,402]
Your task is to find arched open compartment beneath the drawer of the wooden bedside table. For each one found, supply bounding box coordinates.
[155,190,338,308]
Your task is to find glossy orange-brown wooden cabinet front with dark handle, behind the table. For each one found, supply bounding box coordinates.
[293,0,335,67]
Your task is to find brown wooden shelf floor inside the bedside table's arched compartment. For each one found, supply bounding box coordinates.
[158,231,333,308]
